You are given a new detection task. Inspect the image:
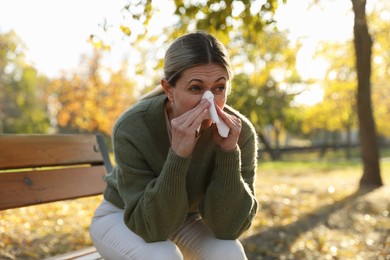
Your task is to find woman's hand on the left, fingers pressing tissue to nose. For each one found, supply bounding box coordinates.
[171,100,210,157]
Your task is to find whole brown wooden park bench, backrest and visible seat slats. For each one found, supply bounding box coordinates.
[0,134,112,259]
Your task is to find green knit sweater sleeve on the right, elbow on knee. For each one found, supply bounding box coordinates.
[199,126,257,239]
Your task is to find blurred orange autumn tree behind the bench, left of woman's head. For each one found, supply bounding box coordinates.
[51,49,135,136]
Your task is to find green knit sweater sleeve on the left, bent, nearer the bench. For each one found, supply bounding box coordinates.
[114,124,190,242]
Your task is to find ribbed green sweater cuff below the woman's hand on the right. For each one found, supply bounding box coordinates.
[215,146,242,190]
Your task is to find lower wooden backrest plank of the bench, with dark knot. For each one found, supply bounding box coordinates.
[0,165,106,210]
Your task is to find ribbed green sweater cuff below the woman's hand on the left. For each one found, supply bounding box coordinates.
[156,149,191,194]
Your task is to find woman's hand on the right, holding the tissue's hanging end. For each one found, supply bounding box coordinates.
[213,105,242,151]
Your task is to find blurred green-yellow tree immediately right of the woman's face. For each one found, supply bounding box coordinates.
[228,72,300,160]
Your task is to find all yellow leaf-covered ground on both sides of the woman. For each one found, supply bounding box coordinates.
[0,163,390,260]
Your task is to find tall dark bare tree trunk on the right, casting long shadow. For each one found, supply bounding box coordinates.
[351,0,383,186]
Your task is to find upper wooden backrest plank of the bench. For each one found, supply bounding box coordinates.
[0,134,103,169]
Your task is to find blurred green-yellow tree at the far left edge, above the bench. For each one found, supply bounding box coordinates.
[0,31,50,133]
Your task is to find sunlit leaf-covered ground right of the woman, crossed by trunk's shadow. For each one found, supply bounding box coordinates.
[242,161,390,260]
